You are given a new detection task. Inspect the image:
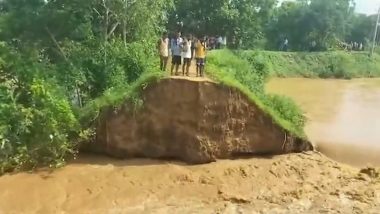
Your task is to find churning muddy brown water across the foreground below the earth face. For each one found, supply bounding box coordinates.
[0,152,380,214]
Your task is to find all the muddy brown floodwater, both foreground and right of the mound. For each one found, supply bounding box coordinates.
[0,79,380,214]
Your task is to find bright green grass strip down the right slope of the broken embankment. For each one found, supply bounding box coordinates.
[206,50,306,139]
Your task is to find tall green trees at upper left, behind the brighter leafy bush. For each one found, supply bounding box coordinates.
[0,0,172,100]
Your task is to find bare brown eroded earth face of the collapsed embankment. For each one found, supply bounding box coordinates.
[88,79,313,164]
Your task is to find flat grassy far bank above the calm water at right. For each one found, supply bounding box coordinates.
[237,51,380,79]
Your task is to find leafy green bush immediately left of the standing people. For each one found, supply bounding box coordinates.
[58,40,158,103]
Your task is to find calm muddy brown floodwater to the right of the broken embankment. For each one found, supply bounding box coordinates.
[267,78,380,166]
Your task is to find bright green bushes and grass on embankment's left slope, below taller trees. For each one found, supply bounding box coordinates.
[0,44,165,175]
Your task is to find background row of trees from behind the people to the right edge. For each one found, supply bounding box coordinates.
[169,0,376,50]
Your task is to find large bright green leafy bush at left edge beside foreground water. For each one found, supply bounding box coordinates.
[0,46,80,174]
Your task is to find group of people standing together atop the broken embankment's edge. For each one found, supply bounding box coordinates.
[157,32,207,77]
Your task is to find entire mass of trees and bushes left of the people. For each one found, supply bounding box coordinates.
[0,0,172,174]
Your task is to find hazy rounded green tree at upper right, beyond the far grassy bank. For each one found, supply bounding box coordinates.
[267,0,354,50]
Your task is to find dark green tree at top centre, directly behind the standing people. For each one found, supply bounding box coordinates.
[169,0,275,47]
